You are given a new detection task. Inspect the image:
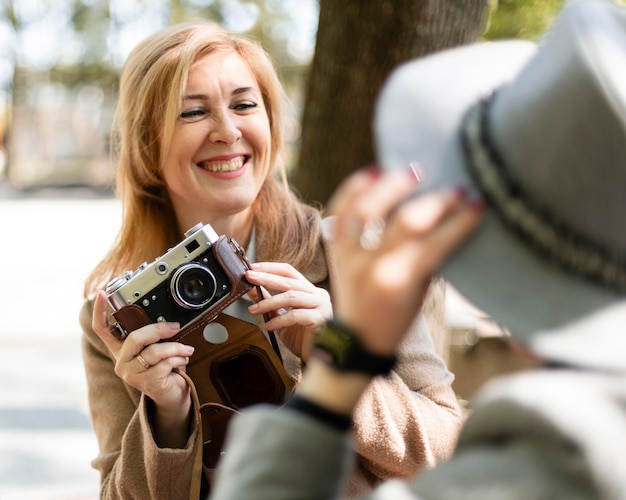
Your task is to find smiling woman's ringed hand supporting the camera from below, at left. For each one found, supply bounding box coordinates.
[92,292,194,448]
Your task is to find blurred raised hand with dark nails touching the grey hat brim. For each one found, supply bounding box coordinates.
[329,170,483,355]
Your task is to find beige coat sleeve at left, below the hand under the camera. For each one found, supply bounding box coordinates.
[80,301,198,500]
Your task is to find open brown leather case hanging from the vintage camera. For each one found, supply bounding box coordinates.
[112,236,295,468]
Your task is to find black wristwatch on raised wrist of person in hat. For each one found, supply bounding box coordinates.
[313,319,397,376]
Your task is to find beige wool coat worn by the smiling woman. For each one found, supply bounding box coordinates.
[80,220,462,500]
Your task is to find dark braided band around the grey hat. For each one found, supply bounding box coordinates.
[462,93,626,292]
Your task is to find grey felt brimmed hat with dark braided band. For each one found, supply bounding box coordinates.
[374,0,626,370]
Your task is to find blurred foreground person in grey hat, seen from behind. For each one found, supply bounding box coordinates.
[212,0,626,500]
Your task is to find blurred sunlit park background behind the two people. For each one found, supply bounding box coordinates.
[0,0,608,500]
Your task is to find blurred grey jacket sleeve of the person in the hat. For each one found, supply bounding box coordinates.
[212,406,354,500]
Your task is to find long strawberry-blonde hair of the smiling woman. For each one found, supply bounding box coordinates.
[85,22,320,296]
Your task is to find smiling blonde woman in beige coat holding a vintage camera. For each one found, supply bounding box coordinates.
[81,17,462,500]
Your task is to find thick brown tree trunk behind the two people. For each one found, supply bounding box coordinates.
[293,0,488,204]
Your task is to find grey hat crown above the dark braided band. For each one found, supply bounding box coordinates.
[489,1,626,254]
